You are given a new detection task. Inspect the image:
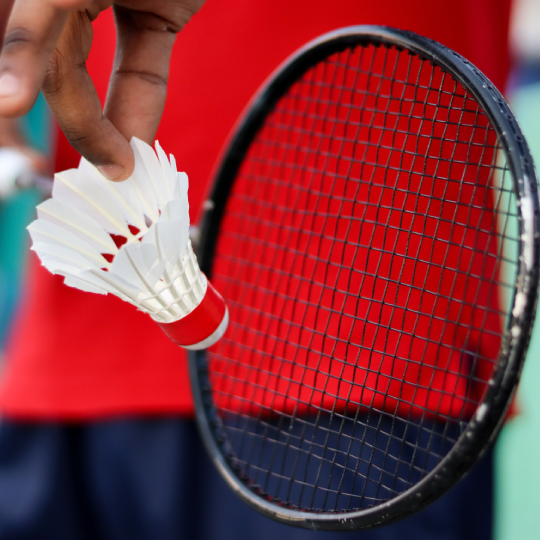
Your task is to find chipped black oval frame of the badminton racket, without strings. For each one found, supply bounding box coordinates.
[189,26,540,530]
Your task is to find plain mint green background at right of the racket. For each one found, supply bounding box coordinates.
[495,84,540,540]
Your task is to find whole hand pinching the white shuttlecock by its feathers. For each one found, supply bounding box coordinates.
[0,0,204,181]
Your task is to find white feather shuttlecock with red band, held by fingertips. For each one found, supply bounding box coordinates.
[28,138,228,349]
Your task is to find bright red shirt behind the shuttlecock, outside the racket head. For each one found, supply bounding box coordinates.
[0,0,510,419]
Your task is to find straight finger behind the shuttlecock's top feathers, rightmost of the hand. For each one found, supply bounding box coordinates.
[105,6,179,144]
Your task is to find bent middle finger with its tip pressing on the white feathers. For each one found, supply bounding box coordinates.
[43,11,134,181]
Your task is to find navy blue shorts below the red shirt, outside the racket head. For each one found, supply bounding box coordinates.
[0,417,493,540]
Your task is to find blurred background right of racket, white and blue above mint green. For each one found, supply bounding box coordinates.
[494,0,540,540]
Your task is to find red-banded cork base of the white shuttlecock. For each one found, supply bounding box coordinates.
[158,281,228,349]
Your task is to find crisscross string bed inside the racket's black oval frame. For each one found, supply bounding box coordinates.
[207,44,519,512]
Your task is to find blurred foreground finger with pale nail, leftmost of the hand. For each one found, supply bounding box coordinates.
[0,0,85,117]
